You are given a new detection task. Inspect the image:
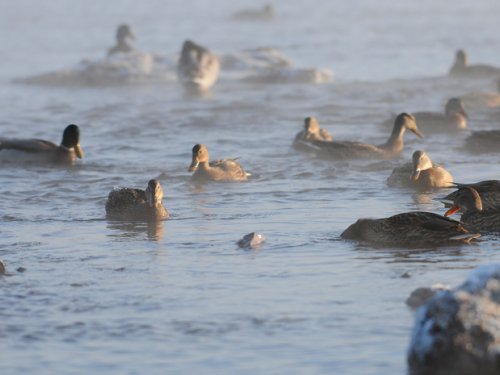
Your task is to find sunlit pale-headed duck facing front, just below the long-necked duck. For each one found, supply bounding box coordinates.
[387,150,453,190]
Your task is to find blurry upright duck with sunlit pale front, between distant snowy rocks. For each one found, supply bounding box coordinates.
[177,40,220,91]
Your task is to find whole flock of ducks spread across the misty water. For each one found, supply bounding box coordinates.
[0,25,500,253]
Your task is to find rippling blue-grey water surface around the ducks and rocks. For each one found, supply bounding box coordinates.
[0,0,500,374]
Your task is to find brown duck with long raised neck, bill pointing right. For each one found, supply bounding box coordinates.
[311,113,423,160]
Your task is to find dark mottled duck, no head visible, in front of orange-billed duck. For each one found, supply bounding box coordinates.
[340,211,480,247]
